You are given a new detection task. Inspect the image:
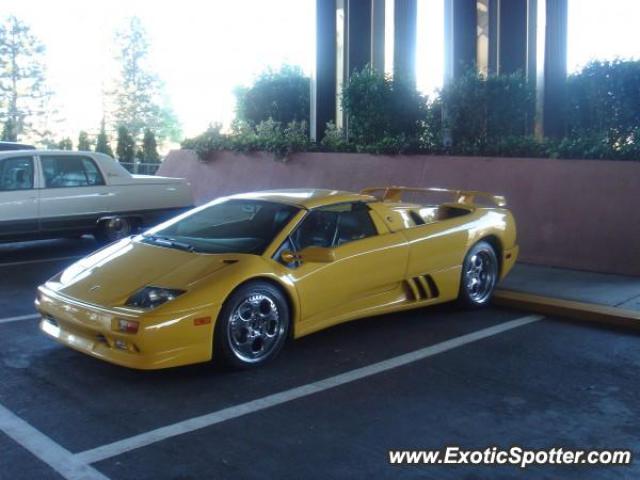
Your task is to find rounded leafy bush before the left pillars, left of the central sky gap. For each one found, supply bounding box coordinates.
[342,66,427,152]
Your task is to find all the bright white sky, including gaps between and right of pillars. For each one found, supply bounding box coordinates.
[0,0,640,138]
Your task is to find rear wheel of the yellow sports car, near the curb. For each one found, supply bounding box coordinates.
[459,242,498,308]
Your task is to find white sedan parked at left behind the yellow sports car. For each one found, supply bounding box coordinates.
[0,150,193,242]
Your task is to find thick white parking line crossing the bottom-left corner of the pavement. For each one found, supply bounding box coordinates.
[0,405,109,480]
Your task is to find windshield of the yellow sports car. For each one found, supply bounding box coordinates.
[142,199,299,255]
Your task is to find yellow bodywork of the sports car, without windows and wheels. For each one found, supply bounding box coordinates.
[36,187,518,369]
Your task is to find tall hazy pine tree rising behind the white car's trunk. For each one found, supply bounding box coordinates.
[108,17,180,141]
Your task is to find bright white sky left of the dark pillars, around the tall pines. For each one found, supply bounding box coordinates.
[5,0,314,138]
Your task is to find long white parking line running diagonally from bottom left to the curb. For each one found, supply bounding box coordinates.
[75,315,544,464]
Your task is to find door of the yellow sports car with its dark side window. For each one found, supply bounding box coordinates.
[282,202,408,330]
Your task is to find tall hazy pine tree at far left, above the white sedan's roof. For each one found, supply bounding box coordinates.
[0,16,51,140]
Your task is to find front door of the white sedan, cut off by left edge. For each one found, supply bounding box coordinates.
[0,154,38,239]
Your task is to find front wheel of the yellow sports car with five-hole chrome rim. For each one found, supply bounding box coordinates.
[218,281,290,368]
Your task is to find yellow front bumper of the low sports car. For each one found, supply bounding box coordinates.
[36,287,220,370]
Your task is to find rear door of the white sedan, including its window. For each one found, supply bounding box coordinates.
[40,153,112,232]
